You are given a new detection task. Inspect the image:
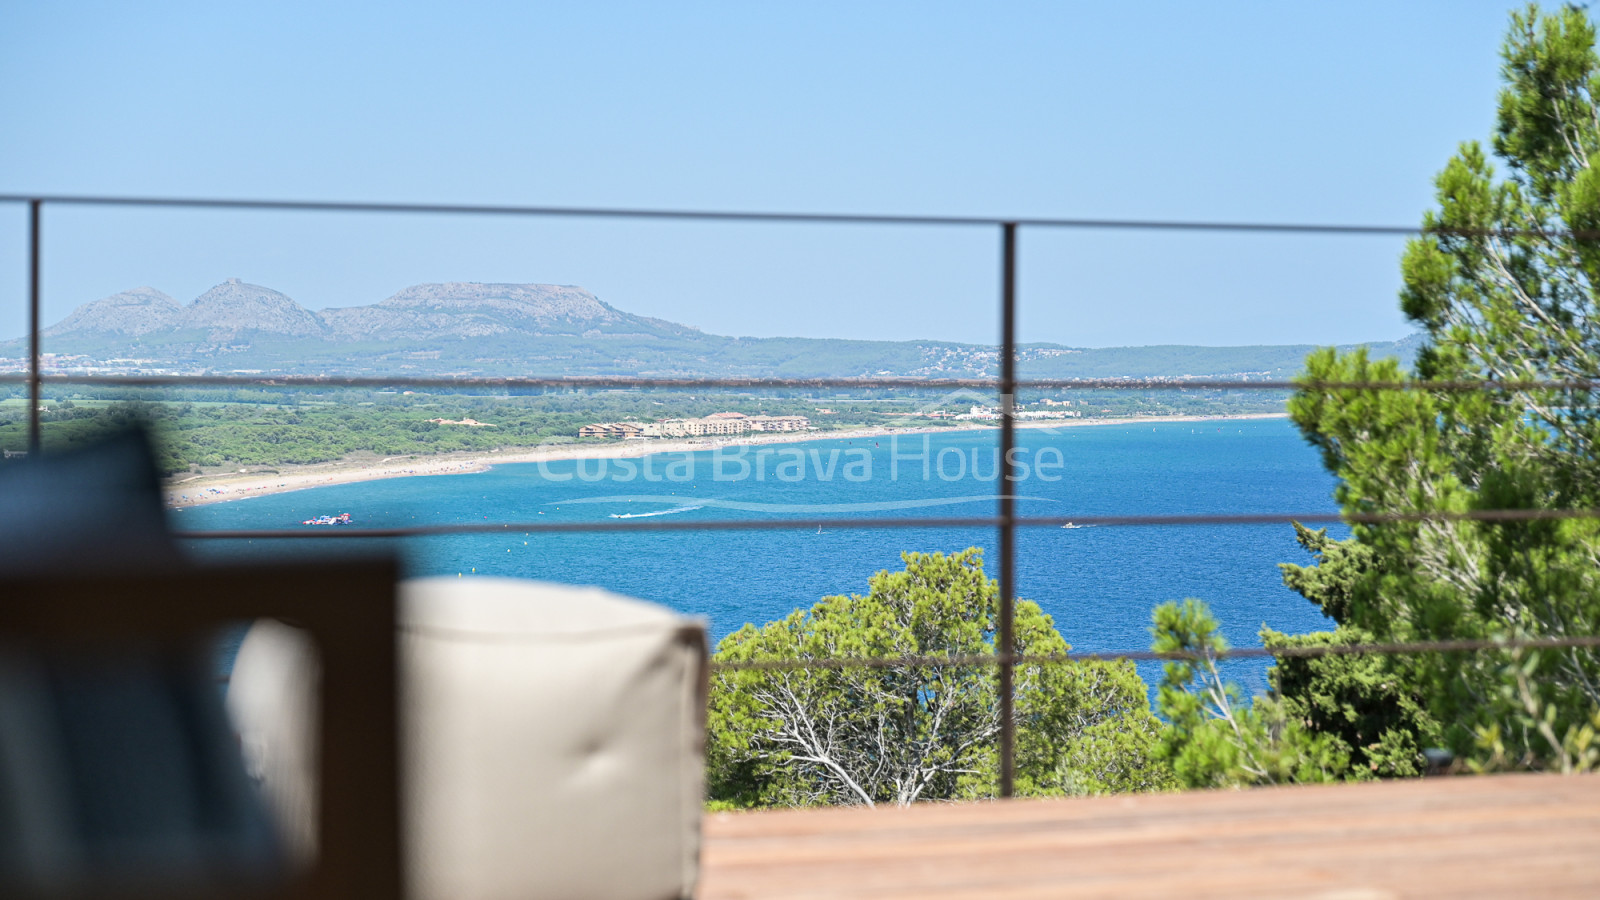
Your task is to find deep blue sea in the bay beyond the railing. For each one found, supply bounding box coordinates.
[176,420,1336,690]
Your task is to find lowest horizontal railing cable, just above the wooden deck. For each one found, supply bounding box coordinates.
[710,636,1600,671]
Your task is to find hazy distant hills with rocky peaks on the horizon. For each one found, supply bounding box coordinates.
[0,279,1416,380]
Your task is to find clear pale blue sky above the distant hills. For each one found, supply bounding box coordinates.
[0,0,1510,346]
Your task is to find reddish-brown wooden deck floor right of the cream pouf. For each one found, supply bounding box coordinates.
[699,775,1600,900]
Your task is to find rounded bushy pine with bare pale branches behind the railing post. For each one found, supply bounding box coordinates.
[707,548,1171,807]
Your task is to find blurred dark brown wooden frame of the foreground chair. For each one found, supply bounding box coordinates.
[0,559,403,900]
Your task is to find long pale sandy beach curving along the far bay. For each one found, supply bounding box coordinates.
[163,413,1288,509]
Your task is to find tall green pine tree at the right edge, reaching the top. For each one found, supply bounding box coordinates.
[1222,6,1600,778]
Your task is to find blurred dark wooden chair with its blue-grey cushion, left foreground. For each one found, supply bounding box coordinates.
[0,429,402,900]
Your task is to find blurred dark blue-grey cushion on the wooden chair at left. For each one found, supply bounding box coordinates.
[0,432,282,895]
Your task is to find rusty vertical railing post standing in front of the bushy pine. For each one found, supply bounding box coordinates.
[995,223,1016,798]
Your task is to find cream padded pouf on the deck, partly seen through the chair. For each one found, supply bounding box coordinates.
[229,578,706,900]
